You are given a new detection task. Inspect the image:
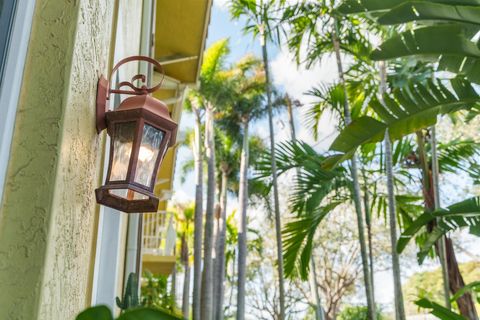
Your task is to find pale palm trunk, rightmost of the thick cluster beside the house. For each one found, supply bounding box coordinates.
[237,120,249,320]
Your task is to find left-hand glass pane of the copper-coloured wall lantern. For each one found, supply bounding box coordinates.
[110,121,136,181]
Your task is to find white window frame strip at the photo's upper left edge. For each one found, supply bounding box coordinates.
[0,0,36,200]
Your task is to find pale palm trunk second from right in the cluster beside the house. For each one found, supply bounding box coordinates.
[213,168,228,320]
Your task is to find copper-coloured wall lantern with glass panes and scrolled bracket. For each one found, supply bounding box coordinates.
[95,56,177,213]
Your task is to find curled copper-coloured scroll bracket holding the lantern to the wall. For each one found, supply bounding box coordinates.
[96,56,165,133]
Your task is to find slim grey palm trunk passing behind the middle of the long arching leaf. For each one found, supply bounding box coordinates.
[379,61,405,320]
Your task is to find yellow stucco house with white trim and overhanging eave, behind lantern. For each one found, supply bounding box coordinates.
[0,0,211,320]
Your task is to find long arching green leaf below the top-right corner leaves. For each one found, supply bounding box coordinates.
[324,78,480,167]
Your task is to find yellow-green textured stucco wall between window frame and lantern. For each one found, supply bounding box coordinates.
[0,0,113,320]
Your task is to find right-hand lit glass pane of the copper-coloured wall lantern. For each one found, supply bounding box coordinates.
[135,124,165,186]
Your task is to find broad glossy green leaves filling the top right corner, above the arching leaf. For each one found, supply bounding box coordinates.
[339,0,480,83]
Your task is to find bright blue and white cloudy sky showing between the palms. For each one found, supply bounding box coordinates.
[174,0,478,312]
